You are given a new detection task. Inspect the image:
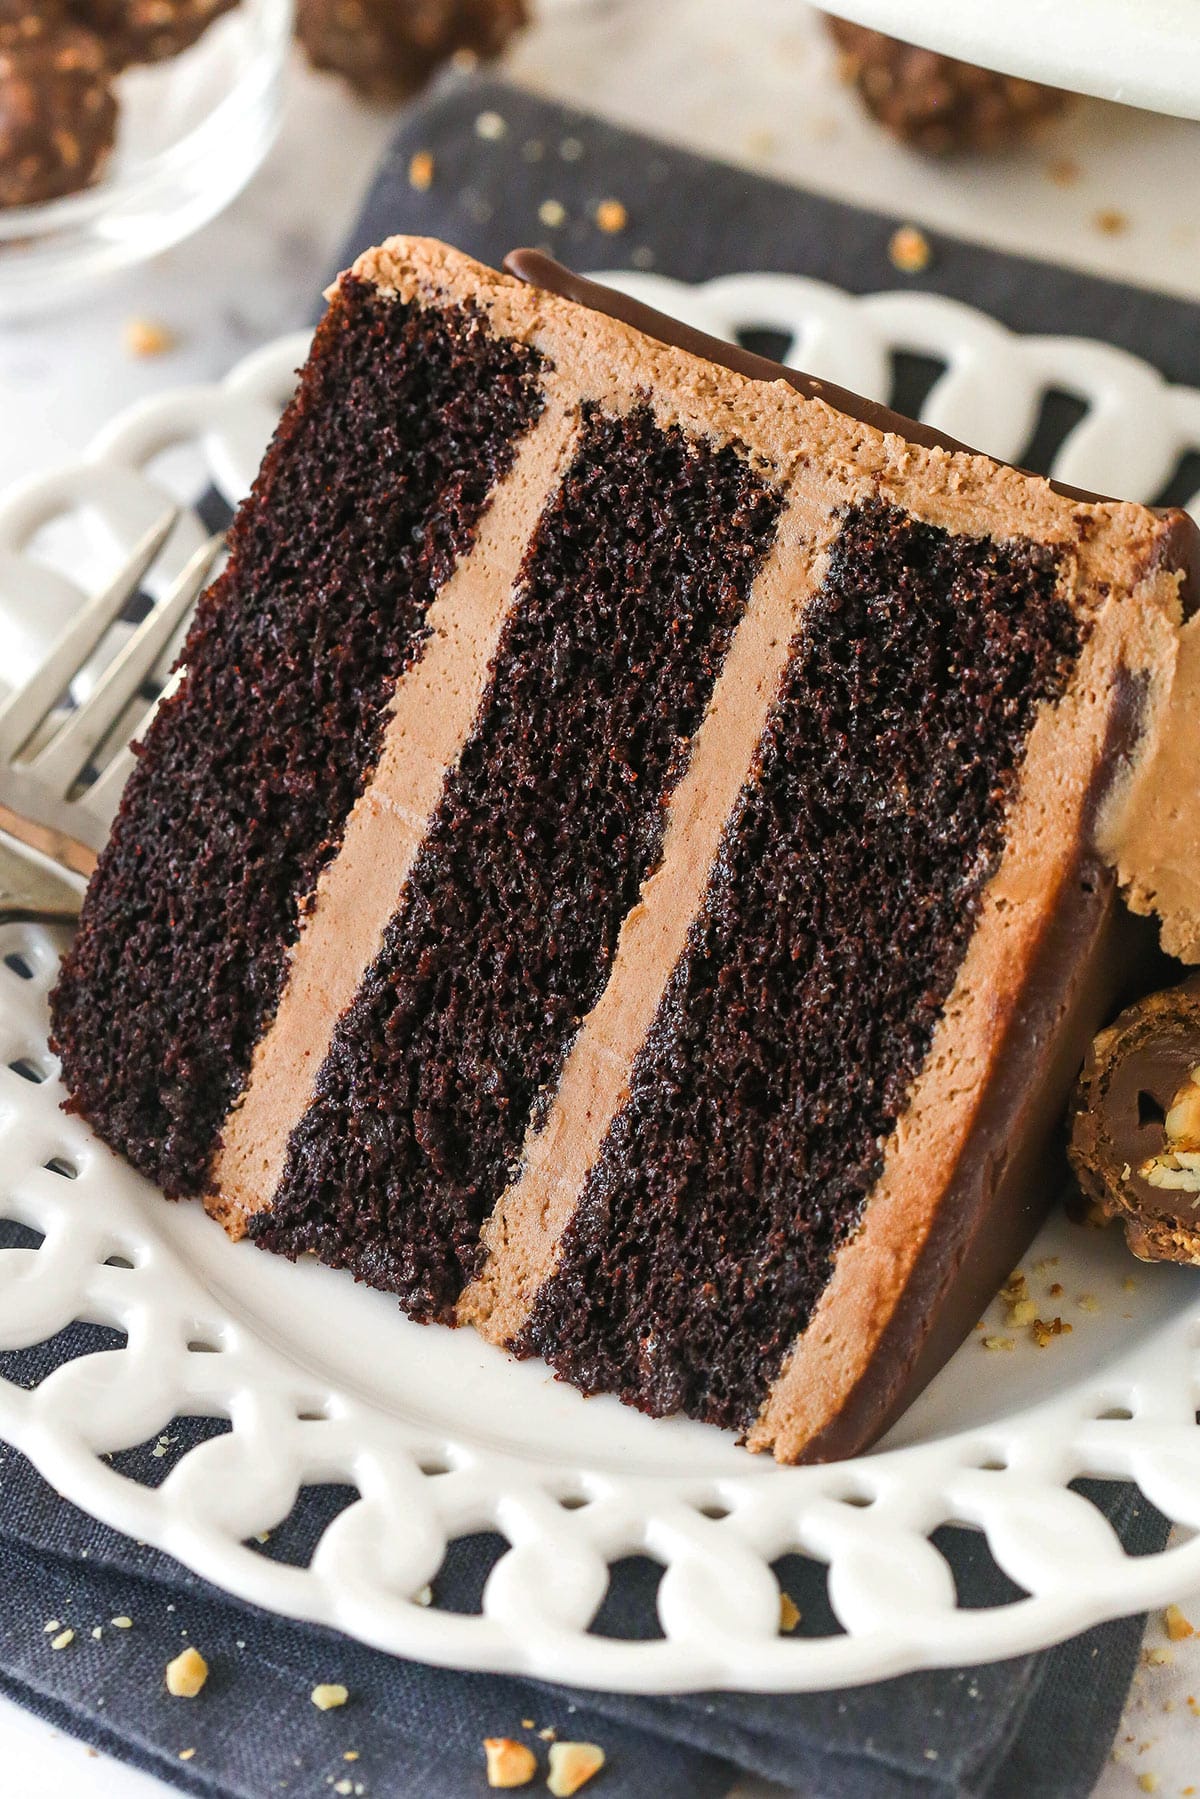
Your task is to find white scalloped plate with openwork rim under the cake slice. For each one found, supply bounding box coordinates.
[0,275,1200,1693]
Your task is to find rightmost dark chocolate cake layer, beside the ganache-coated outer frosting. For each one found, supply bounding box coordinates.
[515,504,1079,1428]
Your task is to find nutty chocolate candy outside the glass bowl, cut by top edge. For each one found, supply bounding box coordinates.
[297,0,527,101]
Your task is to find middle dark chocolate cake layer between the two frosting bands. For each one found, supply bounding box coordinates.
[250,405,779,1317]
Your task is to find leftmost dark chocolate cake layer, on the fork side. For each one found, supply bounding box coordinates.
[52,281,542,1193]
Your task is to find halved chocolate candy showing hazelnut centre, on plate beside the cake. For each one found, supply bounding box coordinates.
[1070,975,1200,1266]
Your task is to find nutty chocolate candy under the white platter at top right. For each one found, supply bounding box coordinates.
[828,18,1067,157]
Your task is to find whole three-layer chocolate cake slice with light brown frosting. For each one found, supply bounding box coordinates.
[54,239,1200,1461]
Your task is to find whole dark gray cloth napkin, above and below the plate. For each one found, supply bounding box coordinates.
[0,70,1200,1799]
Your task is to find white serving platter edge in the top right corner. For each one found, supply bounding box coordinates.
[829,0,1200,119]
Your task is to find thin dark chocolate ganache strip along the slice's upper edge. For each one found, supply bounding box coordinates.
[504,250,1200,617]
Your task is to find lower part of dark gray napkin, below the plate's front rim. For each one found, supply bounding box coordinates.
[0,1316,1166,1799]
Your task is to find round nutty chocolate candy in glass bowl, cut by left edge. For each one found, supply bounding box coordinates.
[0,7,117,207]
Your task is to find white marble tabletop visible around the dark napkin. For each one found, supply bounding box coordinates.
[0,0,1200,1799]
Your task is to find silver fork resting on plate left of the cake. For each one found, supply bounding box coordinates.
[0,507,225,923]
